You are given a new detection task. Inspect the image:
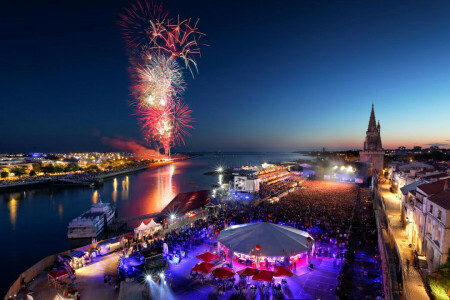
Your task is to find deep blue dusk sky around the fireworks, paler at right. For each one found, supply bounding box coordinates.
[0,0,450,153]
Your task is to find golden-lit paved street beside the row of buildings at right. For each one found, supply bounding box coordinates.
[380,184,430,300]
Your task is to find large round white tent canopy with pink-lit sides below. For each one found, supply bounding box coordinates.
[218,222,314,256]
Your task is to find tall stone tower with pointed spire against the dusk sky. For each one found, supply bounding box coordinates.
[359,104,384,172]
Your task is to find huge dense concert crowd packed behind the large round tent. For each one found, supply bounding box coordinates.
[114,181,381,298]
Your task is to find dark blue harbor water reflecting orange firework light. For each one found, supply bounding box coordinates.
[0,153,307,297]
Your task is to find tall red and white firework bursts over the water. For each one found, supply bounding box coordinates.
[118,0,204,153]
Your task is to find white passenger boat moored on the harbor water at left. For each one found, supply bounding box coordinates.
[67,197,115,239]
